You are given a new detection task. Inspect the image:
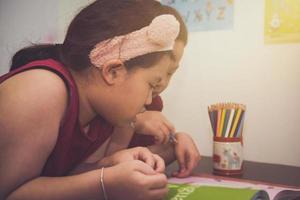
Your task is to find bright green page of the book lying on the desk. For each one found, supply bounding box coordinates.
[166,183,270,200]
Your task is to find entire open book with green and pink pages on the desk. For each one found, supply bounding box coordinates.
[166,175,300,200]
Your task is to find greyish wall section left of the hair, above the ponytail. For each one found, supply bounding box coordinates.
[0,0,93,75]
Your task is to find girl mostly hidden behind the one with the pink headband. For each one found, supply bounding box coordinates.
[106,37,200,178]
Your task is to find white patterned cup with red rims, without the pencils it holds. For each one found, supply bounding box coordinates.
[213,137,243,176]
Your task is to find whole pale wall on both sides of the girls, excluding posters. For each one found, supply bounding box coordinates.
[0,0,300,166]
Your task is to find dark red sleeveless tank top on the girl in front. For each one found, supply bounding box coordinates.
[0,59,113,176]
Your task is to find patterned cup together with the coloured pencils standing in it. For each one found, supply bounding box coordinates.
[208,103,246,176]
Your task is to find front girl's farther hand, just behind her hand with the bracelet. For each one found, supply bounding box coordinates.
[98,147,165,173]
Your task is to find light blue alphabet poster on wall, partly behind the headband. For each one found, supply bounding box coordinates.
[161,0,234,31]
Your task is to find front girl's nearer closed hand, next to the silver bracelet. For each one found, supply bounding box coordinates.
[104,160,168,200]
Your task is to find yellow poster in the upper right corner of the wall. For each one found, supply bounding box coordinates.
[265,0,300,44]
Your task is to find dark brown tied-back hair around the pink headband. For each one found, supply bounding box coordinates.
[10,0,187,70]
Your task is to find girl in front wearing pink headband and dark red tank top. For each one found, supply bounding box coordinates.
[0,0,199,200]
